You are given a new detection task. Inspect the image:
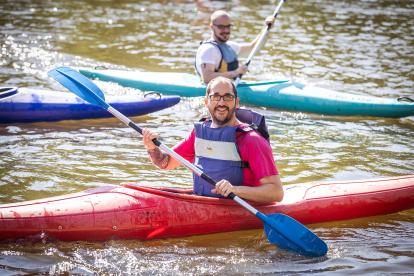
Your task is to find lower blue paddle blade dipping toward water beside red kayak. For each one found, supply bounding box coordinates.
[256,214,328,257]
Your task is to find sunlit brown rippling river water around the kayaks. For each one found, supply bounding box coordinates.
[0,0,414,275]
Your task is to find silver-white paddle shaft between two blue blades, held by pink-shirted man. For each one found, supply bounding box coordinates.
[107,106,259,215]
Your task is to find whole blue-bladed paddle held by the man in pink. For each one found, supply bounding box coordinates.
[47,66,328,257]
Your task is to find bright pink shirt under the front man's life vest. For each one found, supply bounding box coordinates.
[173,124,279,186]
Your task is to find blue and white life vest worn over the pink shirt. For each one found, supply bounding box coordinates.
[193,109,269,198]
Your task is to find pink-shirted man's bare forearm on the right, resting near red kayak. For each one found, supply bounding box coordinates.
[234,184,283,202]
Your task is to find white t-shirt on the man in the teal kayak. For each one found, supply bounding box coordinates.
[196,41,241,73]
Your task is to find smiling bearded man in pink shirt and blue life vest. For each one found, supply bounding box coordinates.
[143,76,283,202]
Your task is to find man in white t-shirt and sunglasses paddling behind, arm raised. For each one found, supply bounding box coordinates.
[195,11,275,84]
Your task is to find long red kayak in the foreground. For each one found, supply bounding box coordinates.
[0,175,414,242]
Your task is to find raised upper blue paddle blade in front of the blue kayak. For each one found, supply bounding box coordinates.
[47,66,109,109]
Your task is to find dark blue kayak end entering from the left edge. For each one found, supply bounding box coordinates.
[0,87,180,124]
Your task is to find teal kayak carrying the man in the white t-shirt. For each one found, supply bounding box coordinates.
[79,69,414,118]
